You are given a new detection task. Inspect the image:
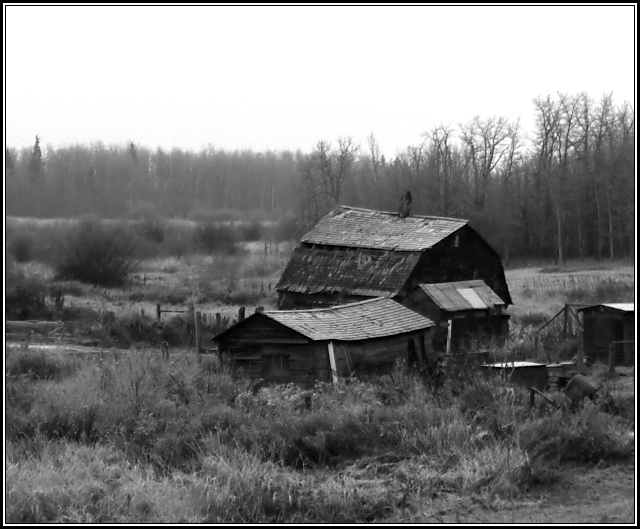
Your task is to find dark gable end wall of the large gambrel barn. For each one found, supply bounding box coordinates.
[409,226,512,303]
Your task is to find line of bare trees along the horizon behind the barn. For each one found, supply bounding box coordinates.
[5,93,635,262]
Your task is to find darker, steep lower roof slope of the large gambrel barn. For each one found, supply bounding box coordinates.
[276,247,420,297]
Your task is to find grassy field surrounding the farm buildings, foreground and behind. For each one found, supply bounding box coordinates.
[5,224,635,523]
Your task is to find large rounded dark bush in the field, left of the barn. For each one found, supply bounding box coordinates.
[55,219,137,287]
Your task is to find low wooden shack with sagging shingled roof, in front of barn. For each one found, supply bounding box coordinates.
[213,298,435,385]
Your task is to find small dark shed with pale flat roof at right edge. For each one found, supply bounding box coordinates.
[578,303,636,365]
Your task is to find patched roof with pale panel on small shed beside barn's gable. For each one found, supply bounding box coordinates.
[416,279,505,312]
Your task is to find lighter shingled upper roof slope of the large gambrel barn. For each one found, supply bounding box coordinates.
[302,206,468,252]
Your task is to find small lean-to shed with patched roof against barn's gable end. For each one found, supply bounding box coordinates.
[402,279,509,351]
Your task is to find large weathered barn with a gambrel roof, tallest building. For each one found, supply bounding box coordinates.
[276,206,512,309]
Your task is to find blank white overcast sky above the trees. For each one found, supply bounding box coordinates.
[5,5,636,154]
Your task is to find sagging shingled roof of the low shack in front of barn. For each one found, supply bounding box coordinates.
[214,298,434,341]
